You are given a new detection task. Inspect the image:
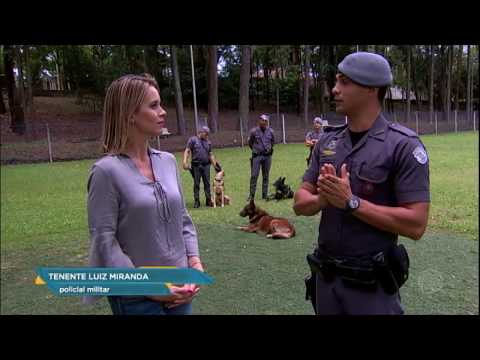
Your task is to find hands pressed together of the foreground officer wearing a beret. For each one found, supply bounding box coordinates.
[317,164,352,209]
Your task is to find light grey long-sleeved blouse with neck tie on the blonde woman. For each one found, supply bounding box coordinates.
[87,148,199,267]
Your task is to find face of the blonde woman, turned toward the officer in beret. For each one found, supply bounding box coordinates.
[133,86,167,136]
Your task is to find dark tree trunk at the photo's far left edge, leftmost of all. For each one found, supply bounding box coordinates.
[5,45,26,135]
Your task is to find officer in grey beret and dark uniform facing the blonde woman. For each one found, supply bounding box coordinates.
[293,52,430,314]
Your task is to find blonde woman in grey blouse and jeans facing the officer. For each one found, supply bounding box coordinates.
[87,74,203,315]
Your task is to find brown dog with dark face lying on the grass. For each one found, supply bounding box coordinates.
[238,200,295,239]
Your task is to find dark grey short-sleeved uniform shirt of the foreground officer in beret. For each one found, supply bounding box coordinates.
[303,115,430,256]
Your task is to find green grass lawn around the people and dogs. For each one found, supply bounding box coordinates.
[1,132,478,314]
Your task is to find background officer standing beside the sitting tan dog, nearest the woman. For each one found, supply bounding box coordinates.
[183,126,217,208]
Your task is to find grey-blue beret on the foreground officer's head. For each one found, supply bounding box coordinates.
[338,52,393,87]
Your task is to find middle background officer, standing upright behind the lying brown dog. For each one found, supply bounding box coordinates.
[248,114,275,200]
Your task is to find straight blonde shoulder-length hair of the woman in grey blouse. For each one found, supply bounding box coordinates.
[102,74,160,155]
